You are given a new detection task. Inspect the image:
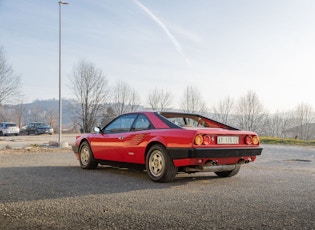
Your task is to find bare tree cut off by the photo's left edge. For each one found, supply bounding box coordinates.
[0,47,21,105]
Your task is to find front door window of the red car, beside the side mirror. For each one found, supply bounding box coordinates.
[104,114,137,133]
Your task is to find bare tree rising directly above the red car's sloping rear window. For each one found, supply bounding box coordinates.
[180,86,206,113]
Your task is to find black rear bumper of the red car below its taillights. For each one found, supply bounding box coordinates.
[167,147,263,160]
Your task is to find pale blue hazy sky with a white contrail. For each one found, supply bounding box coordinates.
[0,0,315,112]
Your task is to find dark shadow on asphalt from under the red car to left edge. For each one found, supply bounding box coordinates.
[0,166,218,203]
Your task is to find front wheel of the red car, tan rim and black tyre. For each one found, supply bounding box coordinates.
[79,141,98,169]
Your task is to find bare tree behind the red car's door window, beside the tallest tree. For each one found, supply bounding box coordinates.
[113,81,140,115]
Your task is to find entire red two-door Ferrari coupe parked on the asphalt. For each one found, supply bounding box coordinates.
[72,112,262,182]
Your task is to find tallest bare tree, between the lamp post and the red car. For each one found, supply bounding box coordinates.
[70,60,109,132]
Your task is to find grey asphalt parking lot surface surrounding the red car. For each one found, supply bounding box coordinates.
[0,140,315,229]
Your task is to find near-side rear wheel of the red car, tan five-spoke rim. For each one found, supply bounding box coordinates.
[145,144,178,182]
